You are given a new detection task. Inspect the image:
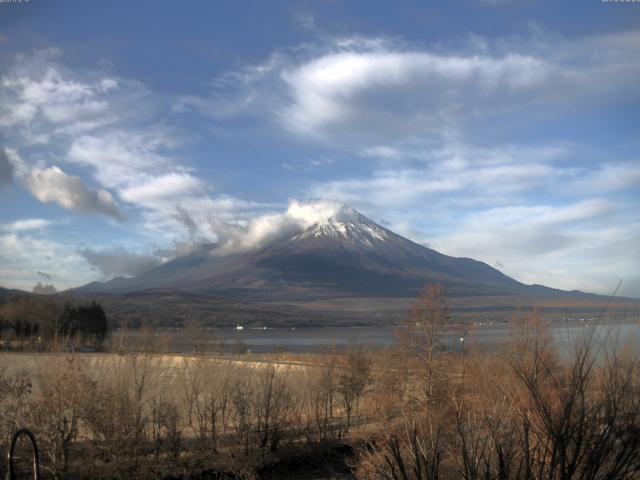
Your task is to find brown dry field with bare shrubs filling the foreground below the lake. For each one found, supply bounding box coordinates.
[0,286,640,480]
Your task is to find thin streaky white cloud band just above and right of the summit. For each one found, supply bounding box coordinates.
[312,143,573,209]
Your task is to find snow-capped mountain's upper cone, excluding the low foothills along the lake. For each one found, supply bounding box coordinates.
[78,205,552,301]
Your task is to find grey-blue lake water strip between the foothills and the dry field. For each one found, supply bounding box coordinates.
[131,322,640,353]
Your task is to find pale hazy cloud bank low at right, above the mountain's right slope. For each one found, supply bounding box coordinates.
[428,199,640,296]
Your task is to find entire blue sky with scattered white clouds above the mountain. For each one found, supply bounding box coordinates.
[0,0,640,297]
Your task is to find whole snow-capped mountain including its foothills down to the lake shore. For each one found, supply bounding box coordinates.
[74,204,638,326]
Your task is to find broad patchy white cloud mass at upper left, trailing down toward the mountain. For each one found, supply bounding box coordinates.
[0,50,242,246]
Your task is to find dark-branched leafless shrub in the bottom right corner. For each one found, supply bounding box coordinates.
[511,316,640,479]
